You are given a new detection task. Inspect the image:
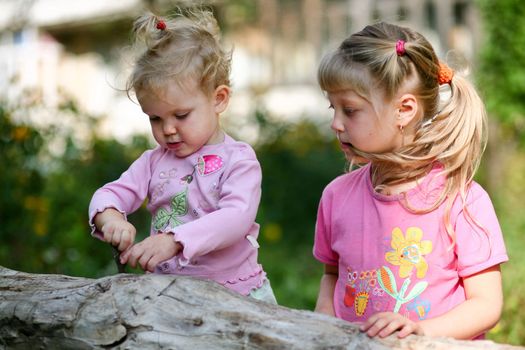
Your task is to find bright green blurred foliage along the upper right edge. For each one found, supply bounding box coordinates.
[478,0,525,192]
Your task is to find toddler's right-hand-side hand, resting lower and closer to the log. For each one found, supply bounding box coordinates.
[120,233,182,272]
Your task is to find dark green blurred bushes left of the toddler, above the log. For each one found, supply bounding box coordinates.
[0,95,150,277]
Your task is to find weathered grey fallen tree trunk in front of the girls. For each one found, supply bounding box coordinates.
[0,267,518,349]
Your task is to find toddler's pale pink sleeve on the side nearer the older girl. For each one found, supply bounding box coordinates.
[171,151,262,260]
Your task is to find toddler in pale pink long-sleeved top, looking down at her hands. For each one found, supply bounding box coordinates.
[89,10,276,303]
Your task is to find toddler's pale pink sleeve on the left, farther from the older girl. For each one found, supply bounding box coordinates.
[89,150,153,238]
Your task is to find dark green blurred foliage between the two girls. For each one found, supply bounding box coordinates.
[233,111,345,309]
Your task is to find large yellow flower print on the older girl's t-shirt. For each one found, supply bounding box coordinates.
[385,227,432,278]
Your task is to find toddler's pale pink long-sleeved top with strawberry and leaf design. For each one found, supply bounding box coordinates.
[89,135,266,295]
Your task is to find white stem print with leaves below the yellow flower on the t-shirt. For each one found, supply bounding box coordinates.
[377,266,428,312]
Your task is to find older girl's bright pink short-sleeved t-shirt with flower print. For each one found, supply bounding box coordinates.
[313,165,508,322]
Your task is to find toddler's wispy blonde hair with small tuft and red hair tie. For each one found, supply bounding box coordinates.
[126,9,231,95]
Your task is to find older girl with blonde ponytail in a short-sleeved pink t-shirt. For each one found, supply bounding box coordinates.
[314,23,508,339]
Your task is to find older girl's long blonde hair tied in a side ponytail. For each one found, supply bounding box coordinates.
[318,22,488,245]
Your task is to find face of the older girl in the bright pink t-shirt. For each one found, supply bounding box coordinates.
[327,90,403,162]
